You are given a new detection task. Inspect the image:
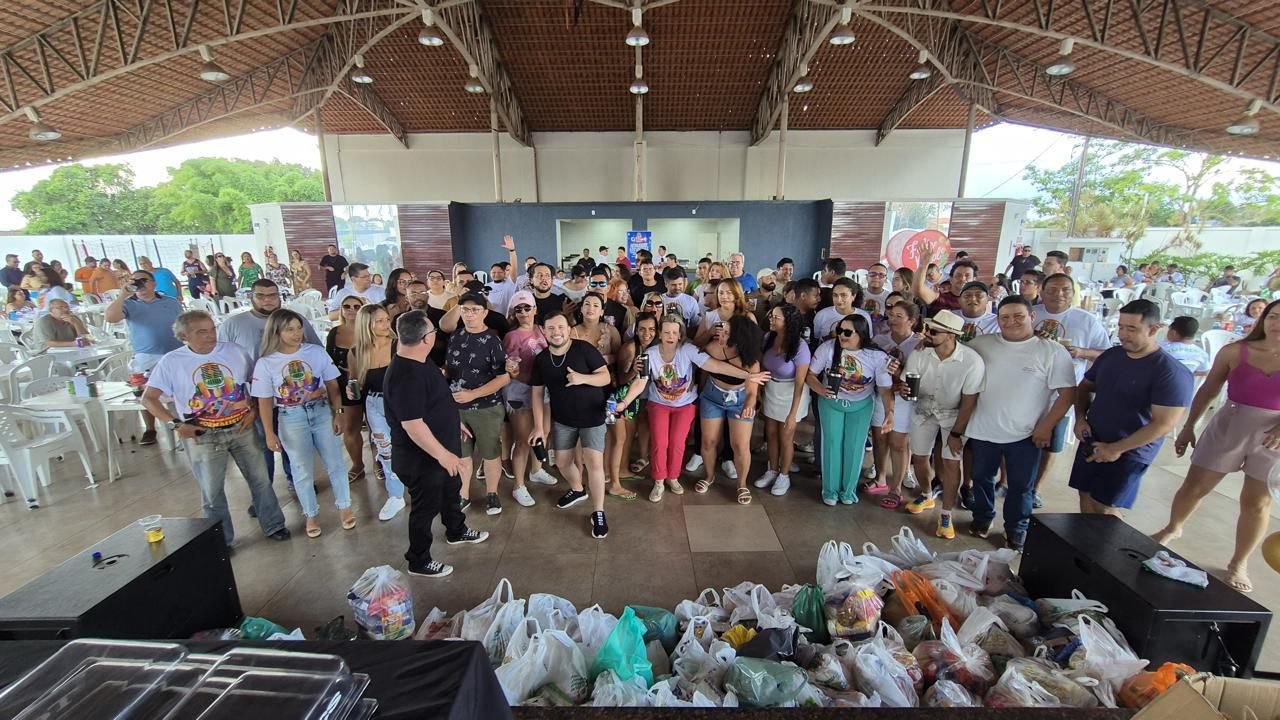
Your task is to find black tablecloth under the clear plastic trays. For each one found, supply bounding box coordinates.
[0,641,511,720]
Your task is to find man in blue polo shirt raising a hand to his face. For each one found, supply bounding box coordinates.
[102,270,182,445]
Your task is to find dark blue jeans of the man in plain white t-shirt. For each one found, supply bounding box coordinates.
[969,438,1041,534]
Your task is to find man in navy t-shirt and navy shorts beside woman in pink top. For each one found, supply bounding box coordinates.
[1069,300,1196,516]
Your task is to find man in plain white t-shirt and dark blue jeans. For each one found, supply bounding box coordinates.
[966,295,1075,551]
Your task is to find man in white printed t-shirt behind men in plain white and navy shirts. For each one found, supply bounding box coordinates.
[1032,273,1111,509]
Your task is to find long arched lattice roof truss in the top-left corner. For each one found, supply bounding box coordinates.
[0,0,417,124]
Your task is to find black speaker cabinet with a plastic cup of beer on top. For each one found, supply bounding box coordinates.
[0,518,243,641]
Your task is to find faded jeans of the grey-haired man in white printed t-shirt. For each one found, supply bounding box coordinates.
[183,417,284,544]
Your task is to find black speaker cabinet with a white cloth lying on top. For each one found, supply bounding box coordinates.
[1019,514,1271,678]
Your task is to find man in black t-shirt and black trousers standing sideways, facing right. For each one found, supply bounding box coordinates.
[383,310,489,578]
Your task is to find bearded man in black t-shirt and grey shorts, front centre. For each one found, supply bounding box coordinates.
[529,313,609,539]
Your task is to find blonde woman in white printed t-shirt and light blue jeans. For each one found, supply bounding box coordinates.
[250,307,356,538]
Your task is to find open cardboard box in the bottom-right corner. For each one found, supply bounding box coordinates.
[1133,674,1280,720]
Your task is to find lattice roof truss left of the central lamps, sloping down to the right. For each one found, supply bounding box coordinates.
[434,0,534,147]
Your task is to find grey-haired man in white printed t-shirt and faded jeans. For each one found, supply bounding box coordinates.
[142,310,289,546]
